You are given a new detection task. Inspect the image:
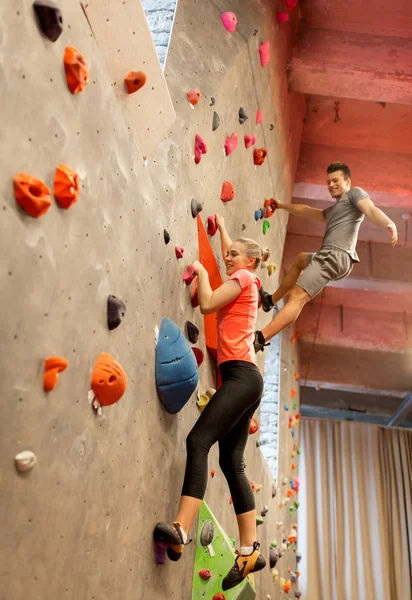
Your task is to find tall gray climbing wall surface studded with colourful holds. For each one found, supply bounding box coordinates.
[0,0,304,600]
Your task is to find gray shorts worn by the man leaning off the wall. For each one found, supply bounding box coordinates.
[296,248,353,298]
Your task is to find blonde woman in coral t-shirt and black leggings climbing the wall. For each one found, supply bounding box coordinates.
[154,215,270,590]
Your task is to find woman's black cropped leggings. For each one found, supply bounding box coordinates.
[182,360,263,514]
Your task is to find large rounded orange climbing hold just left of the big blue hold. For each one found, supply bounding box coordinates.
[92,352,127,406]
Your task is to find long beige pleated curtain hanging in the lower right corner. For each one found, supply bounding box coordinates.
[298,419,412,600]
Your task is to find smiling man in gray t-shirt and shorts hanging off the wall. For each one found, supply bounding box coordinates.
[254,162,398,352]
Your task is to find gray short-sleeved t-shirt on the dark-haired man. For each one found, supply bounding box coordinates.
[322,187,369,262]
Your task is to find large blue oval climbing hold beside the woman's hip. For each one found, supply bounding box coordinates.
[156,317,199,414]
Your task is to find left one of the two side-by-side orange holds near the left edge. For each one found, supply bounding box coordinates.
[13,173,51,219]
